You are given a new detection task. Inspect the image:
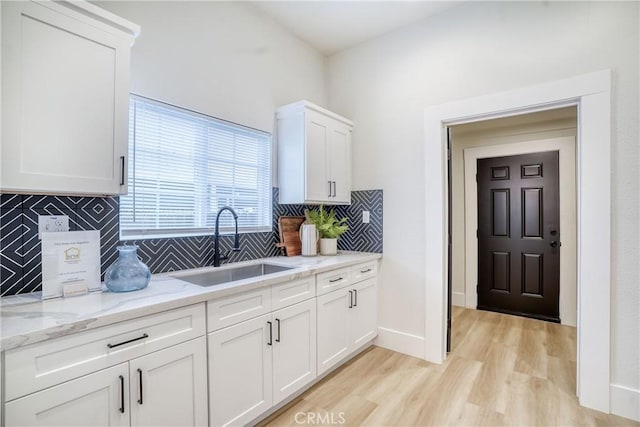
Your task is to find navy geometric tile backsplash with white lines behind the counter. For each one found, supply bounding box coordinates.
[0,188,382,296]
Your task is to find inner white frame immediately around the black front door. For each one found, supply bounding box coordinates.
[464,136,577,326]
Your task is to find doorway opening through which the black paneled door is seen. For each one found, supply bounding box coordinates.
[447,106,577,406]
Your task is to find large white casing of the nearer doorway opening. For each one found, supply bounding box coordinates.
[424,70,611,413]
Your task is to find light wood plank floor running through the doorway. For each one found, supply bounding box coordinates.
[262,307,640,426]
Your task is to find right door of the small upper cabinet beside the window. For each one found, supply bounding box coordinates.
[329,123,351,204]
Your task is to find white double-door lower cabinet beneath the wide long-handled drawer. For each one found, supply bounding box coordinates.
[6,337,207,427]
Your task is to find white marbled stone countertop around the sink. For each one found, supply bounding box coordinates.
[0,252,382,350]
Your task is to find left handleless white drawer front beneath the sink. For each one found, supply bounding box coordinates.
[207,286,271,332]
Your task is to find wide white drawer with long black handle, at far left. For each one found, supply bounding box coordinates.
[5,304,206,401]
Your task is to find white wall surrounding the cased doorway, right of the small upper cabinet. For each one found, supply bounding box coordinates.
[327,2,640,389]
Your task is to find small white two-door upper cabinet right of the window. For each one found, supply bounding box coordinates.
[277,101,353,204]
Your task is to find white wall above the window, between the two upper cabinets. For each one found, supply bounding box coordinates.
[95,1,327,132]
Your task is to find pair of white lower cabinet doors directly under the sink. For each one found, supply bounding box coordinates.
[209,299,316,426]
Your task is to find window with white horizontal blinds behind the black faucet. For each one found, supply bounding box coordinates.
[120,95,271,239]
